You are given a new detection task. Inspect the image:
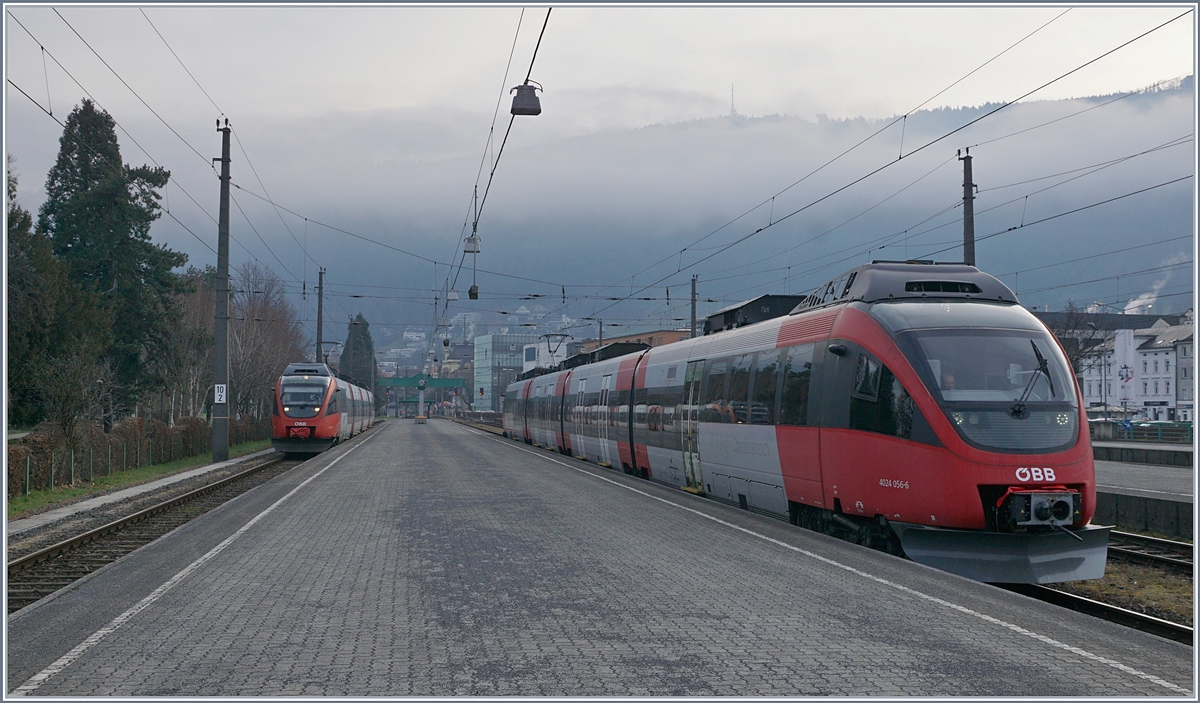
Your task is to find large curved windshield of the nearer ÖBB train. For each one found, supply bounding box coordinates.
[871,302,1079,452]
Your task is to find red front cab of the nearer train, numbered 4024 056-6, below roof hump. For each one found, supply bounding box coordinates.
[811,301,1110,583]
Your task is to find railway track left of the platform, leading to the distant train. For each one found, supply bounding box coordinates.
[7,458,301,614]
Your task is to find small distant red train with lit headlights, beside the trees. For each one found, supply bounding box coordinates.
[271,363,374,456]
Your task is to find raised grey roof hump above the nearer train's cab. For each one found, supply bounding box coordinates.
[791,262,1018,314]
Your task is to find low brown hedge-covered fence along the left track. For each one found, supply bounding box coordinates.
[8,417,271,497]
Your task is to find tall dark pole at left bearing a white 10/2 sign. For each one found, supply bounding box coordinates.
[212,119,230,462]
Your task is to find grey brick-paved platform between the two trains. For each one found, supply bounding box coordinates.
[7,421,1194,698]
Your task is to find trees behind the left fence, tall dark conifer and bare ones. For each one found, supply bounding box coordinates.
[6,100,307,444]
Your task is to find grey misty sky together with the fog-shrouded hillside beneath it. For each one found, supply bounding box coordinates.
[5,4,1195,340]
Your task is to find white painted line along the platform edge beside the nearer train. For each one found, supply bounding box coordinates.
[482,427,1192,696]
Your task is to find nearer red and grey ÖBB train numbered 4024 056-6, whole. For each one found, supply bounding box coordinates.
[504,262,1111,583]
